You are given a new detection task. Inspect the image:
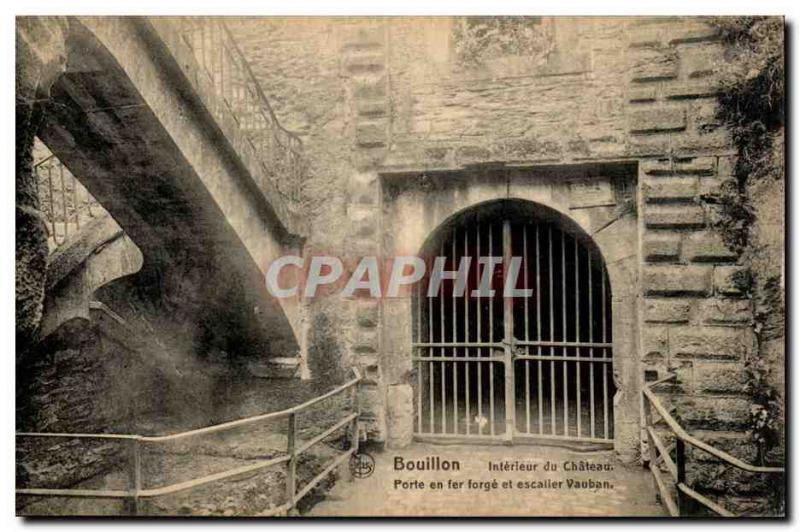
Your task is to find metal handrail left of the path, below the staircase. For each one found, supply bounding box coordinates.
[16,368,362,515]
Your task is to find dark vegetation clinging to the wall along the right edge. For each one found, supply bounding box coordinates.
[712,17,785,462]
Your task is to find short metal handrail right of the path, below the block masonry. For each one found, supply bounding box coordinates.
[642,373,786,517]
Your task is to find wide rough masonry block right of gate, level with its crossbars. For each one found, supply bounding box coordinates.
[669,326,753,360]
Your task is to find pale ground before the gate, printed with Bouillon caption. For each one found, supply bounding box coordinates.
[307,444,667,517]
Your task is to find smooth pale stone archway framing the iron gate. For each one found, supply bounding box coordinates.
[381,168,641,461]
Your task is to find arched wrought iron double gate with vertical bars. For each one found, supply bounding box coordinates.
[413,212,615,443]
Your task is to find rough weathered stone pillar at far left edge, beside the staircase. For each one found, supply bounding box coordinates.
[16,17,67,356]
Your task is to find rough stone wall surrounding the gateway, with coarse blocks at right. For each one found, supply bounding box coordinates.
[235,18,768,466]
